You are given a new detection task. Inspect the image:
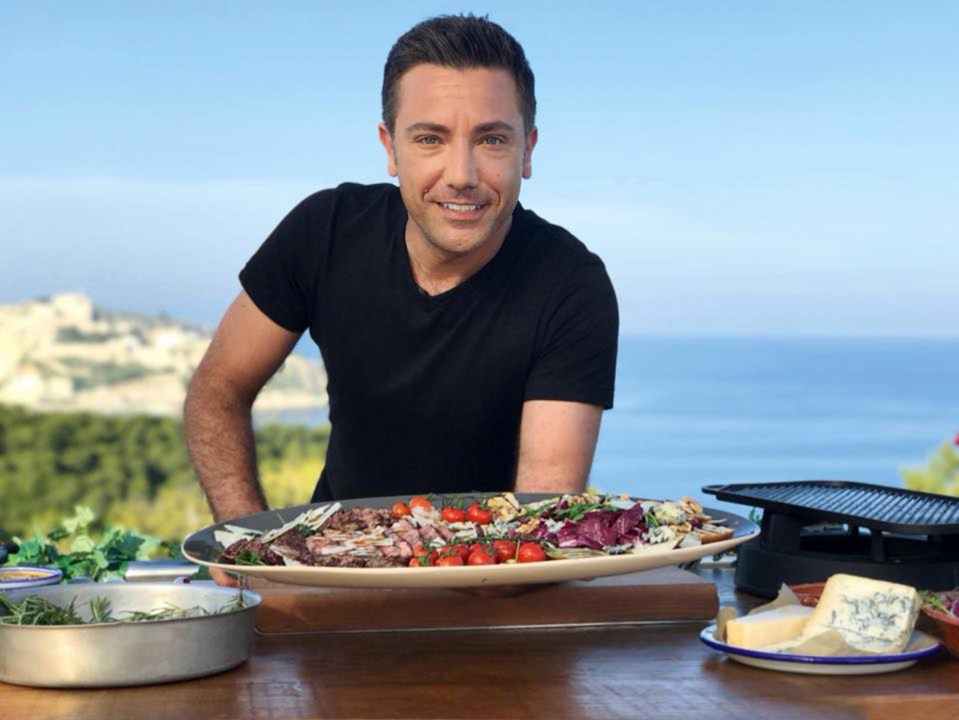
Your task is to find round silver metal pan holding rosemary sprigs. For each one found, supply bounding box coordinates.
[0,583,261,687]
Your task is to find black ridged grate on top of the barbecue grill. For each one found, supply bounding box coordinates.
[703,480,959,535]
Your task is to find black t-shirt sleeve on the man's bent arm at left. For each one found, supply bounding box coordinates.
[240,191,331,333]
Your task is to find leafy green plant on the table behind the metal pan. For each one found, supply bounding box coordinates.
[6,506,162,582]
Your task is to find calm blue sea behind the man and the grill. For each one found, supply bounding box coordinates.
[264,336,959,514]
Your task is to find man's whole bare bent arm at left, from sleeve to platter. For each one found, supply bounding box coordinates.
[183,292,299,520]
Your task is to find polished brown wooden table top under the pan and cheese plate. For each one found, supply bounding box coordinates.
[0,569,959,720]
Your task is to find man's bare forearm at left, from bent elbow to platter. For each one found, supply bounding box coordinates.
[183,380,267,521]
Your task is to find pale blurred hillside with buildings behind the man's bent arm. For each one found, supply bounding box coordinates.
[0,293,326,416]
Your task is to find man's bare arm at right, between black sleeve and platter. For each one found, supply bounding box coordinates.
[515,400,603,493]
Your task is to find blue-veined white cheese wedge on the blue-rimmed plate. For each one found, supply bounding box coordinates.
[803,574,922,654]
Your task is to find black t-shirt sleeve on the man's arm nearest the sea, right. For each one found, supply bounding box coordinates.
[524,259,619,410]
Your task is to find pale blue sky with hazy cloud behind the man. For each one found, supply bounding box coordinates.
[0,0,959,337]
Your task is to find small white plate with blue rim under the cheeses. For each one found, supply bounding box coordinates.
[699,625,939,675]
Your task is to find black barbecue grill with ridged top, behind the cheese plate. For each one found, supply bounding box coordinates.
[703,480,959,597]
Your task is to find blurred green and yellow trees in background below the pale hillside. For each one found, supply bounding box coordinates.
[0,406,329,540]
